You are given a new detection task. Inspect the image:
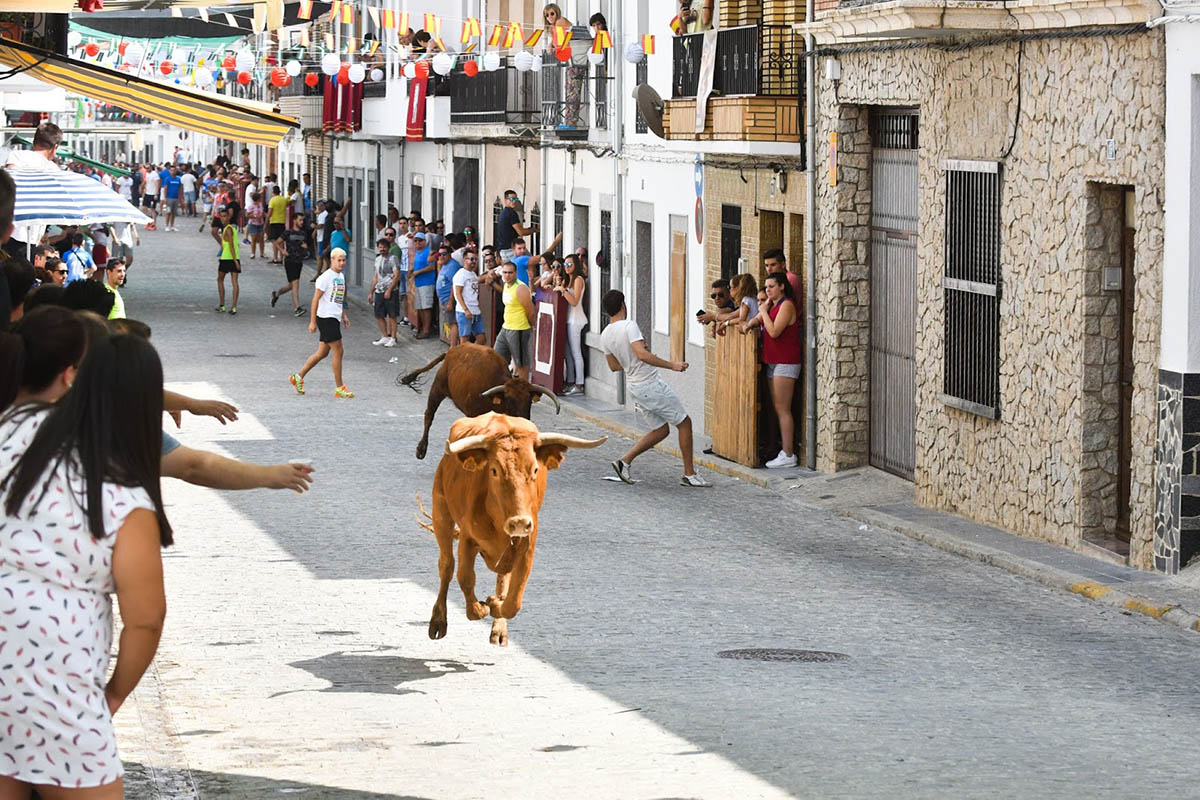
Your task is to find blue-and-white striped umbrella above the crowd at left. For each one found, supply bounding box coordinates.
[8,169,150,228]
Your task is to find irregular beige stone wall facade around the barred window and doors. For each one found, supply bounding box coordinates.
[814,31,1165,567]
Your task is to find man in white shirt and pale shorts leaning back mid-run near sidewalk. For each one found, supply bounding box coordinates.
[600,289,712,487]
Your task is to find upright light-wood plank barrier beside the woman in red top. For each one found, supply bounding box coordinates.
[710,331,760,467]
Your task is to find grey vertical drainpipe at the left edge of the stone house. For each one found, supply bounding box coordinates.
[804,2,817,469]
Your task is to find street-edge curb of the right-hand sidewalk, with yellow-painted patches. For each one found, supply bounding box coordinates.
[563,401,1200,632]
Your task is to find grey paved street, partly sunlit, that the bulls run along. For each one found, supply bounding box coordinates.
[118,221,1200,798]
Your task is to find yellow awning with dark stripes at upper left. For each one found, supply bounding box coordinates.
[0,37,299,148]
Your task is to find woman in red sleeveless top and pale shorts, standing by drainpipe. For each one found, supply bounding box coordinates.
[758,272,804,469]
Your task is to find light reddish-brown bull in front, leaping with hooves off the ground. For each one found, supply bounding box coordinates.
[418,413,607,645]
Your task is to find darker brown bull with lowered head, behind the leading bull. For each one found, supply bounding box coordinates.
[396,344,562,458]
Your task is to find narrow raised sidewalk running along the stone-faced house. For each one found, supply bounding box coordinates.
[560,397,1200,632]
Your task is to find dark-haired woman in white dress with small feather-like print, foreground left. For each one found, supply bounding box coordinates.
[0,335,172,800]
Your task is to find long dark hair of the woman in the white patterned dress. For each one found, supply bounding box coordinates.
[0,333,173,547]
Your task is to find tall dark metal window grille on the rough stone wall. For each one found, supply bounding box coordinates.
[941,160,1001,419]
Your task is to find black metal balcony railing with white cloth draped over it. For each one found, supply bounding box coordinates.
[671,25,804,98]
